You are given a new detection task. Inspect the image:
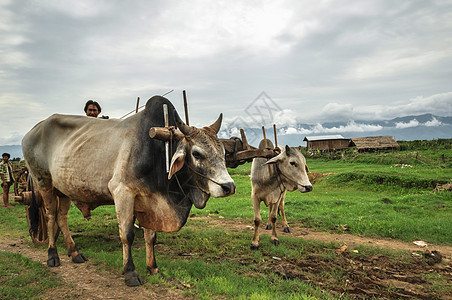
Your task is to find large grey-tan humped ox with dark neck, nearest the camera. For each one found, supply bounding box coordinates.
[22,96,235,286]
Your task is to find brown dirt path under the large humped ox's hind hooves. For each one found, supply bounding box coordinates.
[0,237,185,299]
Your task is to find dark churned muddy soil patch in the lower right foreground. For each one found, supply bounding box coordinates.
[265,251,452,299]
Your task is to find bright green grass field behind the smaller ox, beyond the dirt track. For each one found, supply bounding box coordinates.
[193,154,452,245]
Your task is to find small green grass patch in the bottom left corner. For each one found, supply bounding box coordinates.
[0,252,59,299]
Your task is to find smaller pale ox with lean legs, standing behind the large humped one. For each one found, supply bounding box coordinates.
[251,140,312,250]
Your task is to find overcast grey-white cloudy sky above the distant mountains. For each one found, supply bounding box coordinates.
[0,0,452,145]
